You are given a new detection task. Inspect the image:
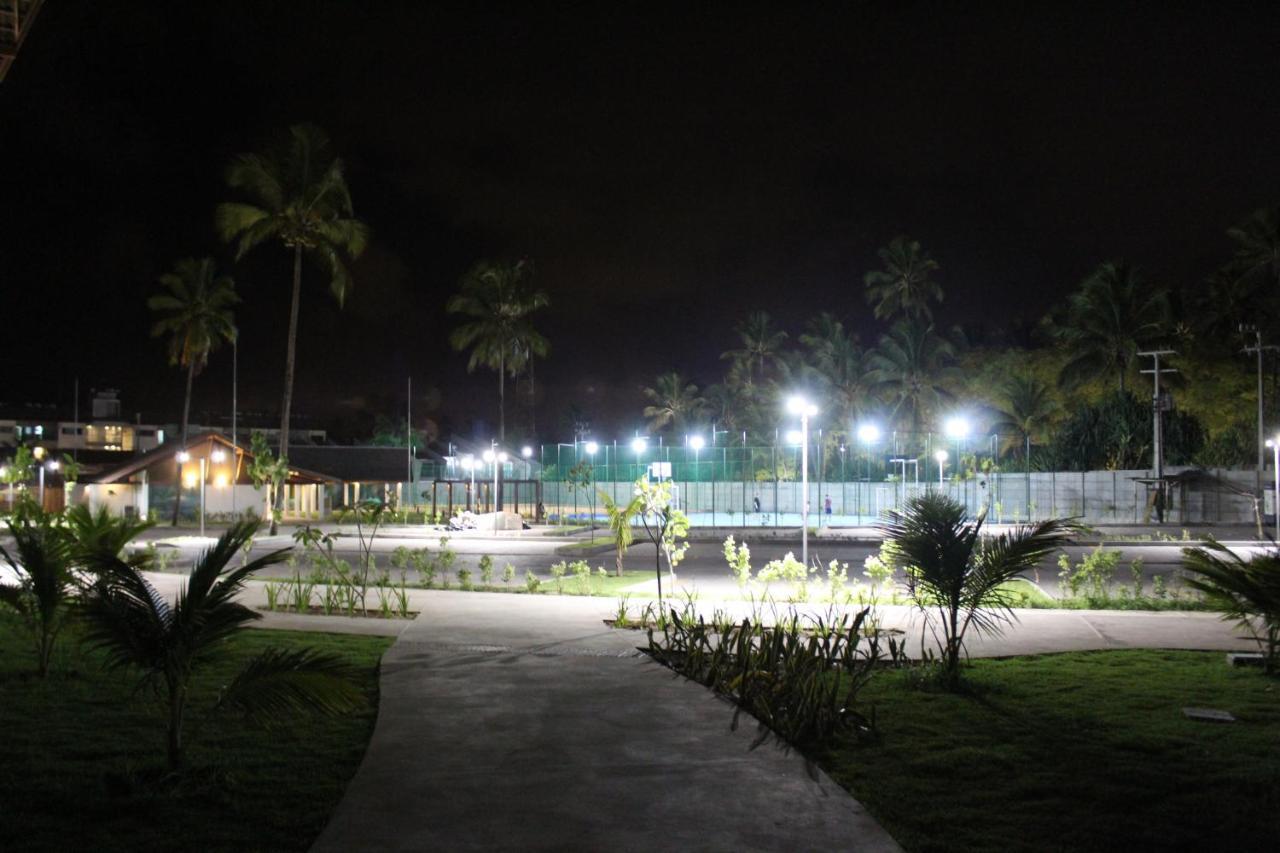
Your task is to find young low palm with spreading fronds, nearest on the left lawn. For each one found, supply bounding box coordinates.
[84,521,362,770]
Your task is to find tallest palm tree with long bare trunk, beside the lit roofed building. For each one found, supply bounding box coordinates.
[215,124,369,522]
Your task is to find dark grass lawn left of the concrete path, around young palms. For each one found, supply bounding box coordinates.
[0,616,392,852]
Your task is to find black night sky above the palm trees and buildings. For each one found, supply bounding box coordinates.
[0,0,1280,439]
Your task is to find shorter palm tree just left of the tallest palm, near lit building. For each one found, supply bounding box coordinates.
[147,257,239,524]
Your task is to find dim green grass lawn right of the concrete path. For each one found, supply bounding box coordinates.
[814,651,1280,852]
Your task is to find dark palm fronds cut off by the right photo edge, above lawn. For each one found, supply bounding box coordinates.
[1183,540,1280,675]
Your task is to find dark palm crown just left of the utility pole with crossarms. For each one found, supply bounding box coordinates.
[1056,261,1169,391]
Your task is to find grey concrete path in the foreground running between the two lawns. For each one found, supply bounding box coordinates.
[312,592,899,852]
